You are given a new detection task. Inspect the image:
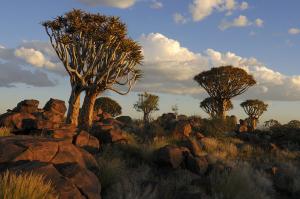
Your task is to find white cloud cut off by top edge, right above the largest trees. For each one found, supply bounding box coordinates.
[77,0,136,9]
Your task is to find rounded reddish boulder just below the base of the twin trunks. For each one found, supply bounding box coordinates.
[74,131,100,153]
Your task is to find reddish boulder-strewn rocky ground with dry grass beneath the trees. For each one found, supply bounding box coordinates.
[0,99,300,199]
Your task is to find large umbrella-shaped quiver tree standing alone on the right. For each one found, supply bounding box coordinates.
[194,66,256,119]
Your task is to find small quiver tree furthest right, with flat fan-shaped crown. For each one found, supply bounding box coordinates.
[241,99,268,130]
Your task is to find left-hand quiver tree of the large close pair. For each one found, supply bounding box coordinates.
[42,10,94,126]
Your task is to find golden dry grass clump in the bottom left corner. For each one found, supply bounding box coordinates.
[0,171,58,199]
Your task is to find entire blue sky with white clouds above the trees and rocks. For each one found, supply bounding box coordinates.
[0,0,300,122]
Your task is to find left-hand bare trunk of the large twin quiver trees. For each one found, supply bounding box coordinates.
[66,88,81,126]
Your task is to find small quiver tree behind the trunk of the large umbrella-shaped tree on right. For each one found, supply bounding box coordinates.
[200,97,233,118]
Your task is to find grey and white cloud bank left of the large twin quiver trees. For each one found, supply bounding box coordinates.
[0,41,65,87]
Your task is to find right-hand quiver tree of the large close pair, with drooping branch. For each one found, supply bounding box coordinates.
[81,15,143,129]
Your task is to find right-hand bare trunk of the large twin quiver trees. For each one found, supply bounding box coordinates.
[80,91,100,130]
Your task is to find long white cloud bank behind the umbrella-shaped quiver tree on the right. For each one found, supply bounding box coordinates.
[135,33,300,101]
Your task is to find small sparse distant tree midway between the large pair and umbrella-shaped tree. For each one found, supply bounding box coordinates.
[133,92,159,125]
